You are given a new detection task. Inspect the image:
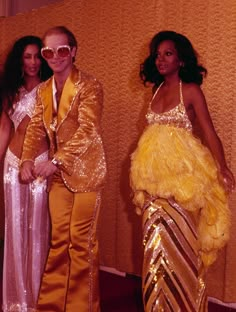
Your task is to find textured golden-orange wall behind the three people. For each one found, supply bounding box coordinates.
[0,0,236,302]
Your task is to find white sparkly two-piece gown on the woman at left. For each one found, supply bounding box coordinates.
[3,88,49,312]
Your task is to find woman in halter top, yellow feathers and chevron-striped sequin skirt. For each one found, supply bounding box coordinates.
[130,31,235,312]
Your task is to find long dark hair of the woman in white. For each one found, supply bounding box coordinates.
[0,36,52,112]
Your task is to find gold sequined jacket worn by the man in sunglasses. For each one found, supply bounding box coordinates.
[22,66,106,192]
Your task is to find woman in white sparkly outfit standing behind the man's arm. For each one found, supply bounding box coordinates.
[0,36,51,312]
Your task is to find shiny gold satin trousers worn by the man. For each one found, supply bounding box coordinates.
[37,179,100,312]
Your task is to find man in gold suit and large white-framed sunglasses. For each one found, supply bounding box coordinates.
[21,26,106,312]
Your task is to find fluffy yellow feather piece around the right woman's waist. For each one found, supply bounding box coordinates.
[130,124,230,266]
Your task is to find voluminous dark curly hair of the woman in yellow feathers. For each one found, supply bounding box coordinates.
[140,31,207,86]
